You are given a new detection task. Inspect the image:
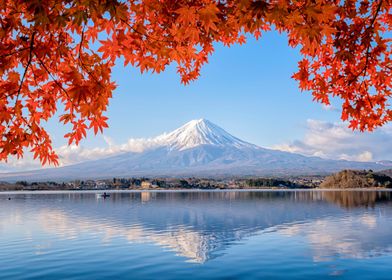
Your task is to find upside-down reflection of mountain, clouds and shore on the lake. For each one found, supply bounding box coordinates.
[4,191,392,263]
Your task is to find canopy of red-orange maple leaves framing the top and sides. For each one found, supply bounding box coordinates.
[0,0,392,164]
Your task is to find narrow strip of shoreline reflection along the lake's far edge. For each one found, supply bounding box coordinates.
[23,190,392,208]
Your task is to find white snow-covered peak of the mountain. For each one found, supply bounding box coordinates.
[158,119,255,151]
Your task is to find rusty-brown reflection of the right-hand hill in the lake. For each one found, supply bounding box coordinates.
[323,191,392,209]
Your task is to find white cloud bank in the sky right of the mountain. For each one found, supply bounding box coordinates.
[273,120,392,161]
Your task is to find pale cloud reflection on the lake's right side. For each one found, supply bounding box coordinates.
[277,213,392,262]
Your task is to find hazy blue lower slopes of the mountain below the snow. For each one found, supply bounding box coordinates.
[0,144,385,182]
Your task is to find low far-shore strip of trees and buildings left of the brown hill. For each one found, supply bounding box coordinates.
[0,176,322,191]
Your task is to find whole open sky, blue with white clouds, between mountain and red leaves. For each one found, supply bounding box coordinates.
[0,32,392,172]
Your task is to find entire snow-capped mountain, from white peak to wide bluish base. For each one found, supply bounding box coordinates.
[0,119,385,181]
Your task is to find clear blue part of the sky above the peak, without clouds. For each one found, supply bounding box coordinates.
[49,32,340,147]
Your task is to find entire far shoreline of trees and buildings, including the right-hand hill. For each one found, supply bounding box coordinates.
[0,170,392,191]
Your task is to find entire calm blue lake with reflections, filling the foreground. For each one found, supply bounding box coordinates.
[0,191,392,279]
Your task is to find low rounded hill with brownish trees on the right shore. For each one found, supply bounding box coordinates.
[320,170,392,189]
